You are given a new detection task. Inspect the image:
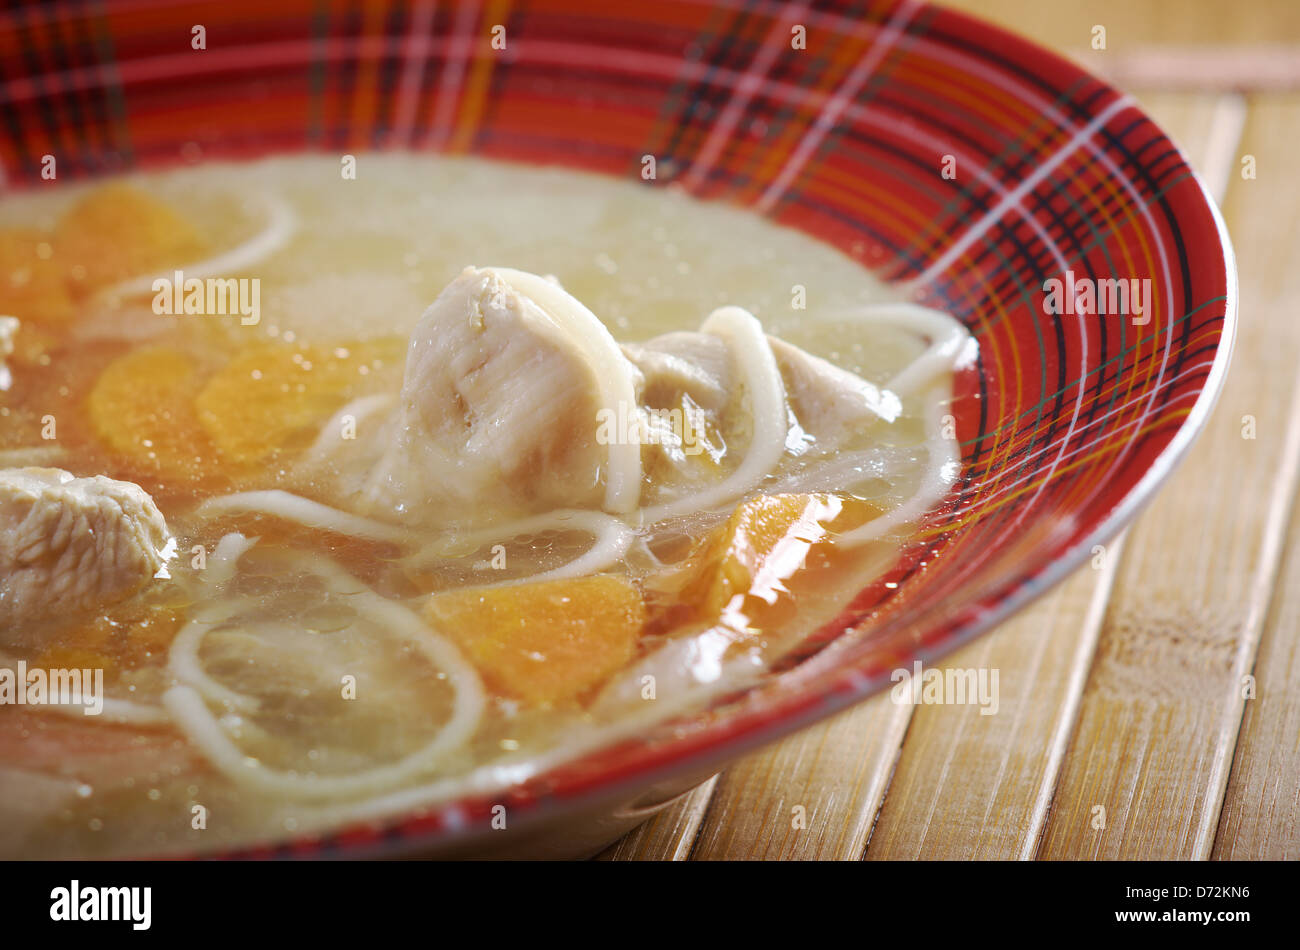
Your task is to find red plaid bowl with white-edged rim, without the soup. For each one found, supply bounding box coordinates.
[0,0,1236,856]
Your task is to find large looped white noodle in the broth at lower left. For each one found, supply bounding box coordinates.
[163,556,488,798]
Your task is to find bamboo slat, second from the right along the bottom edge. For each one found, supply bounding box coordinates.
[1039,97,1300,859]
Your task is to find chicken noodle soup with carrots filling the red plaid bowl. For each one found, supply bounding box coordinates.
[0,155,974,856]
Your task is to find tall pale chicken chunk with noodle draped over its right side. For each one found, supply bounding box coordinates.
[363,268,641,520]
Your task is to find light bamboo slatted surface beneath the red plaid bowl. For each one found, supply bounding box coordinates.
[602,0,1300,860]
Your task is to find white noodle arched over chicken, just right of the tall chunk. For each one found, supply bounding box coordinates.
[641,307,789,525]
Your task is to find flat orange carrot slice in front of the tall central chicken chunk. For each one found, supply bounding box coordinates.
[426,574,645,706]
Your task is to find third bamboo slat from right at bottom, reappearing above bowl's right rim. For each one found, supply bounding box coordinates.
[867,95,1240,860]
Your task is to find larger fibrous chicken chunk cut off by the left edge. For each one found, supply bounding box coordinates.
[0,468,168,639]
